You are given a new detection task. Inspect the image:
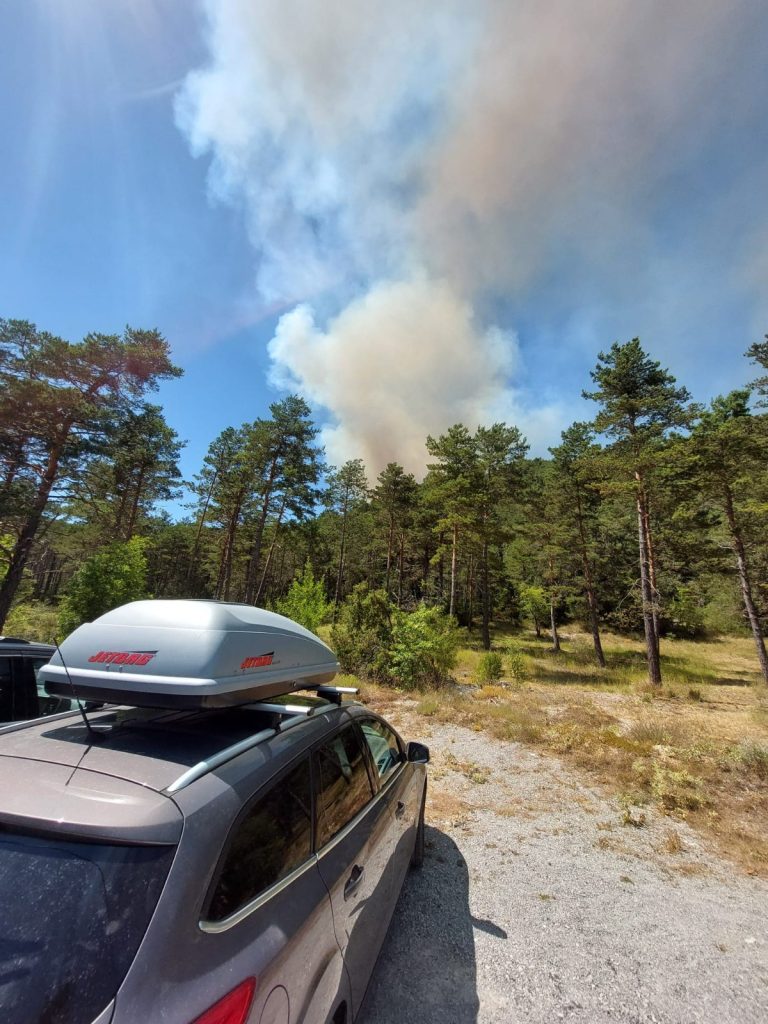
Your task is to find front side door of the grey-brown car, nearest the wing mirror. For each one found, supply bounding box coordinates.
[355,715,421,907]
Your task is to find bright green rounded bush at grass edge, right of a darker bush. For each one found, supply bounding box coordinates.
[388,605,460,689]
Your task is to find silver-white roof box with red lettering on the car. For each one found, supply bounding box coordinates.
[40,601,339,708]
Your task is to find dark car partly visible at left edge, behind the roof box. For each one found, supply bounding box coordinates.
[0,637,75,725]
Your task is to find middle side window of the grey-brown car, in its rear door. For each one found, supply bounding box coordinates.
[316,725,373,848]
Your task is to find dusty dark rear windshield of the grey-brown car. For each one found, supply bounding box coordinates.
[0,831,173,1024]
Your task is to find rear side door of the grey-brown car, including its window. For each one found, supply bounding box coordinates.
[313,722,392,1015]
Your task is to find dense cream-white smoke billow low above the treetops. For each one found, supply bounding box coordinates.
[269,276,563,474]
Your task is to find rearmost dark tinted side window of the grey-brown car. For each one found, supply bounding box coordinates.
[208,761,312,921]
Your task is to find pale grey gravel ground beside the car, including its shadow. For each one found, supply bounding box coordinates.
[359,710,768,1024]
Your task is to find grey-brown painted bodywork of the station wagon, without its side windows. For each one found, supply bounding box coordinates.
[0,692,425,1024]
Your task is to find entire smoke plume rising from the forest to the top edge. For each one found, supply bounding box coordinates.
[177,0,760,468]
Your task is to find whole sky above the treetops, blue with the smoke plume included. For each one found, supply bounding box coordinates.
[0,0,768,505]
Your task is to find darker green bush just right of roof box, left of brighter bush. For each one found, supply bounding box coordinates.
[331,583,393,680]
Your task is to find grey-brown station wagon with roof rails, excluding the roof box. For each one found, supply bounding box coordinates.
[0,697,429,1024]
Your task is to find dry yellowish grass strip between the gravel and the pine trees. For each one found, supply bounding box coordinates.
[365,632,768,877]
